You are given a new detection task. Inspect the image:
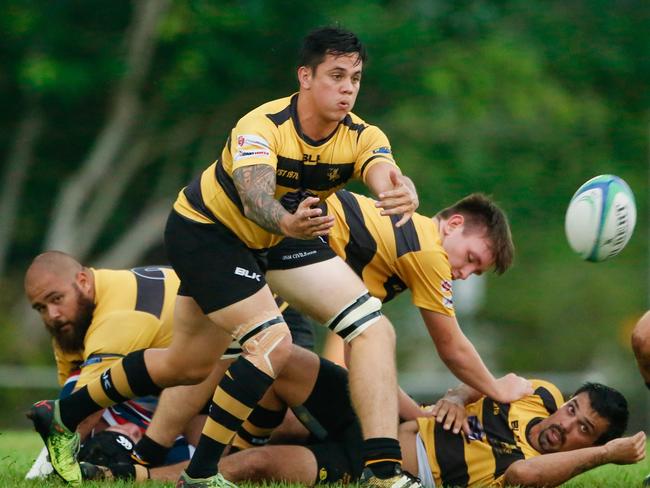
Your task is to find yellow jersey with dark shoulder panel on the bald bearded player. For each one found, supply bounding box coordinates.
[53,266,179,388]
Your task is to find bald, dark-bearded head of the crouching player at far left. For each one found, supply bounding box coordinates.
[26,273,95,352]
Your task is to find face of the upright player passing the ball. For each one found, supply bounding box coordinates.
[299,53,363,122]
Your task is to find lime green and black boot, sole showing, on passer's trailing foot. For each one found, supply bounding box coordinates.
[27,400,81,485]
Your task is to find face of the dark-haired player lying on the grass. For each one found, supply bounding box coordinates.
[537,391,608,454]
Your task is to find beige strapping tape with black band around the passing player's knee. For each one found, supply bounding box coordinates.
[233,315,290,378]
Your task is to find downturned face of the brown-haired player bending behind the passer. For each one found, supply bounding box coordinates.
[442,223,494,280]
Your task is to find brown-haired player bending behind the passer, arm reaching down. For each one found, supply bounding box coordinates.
[106,191,532,472]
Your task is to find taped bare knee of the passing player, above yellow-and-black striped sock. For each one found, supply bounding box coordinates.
[235,315,292,378]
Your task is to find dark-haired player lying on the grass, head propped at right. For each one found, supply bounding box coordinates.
[82,348,645,487]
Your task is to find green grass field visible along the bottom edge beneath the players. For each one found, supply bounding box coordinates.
[0,431,650,488]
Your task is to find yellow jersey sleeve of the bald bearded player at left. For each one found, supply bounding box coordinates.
[77,311,160,388]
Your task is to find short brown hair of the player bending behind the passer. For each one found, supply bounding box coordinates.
[436,193,515,274]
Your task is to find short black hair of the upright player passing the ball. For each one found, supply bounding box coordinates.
[298,27,368,70]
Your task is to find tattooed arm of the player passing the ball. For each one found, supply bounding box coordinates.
[232,164,287,234]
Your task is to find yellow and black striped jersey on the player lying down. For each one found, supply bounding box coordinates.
[418,380,564,487]
